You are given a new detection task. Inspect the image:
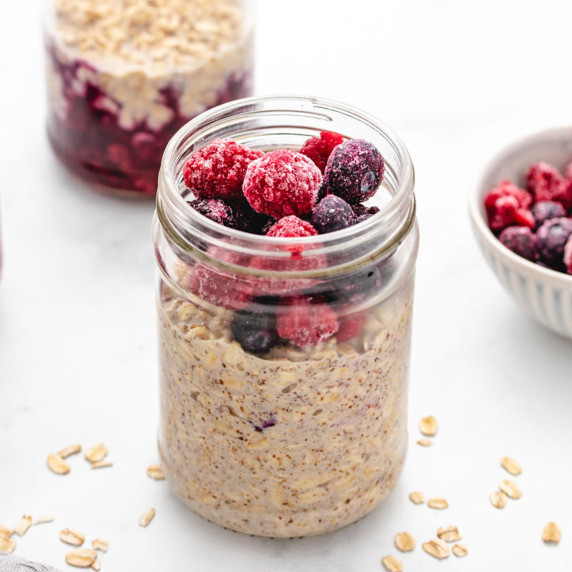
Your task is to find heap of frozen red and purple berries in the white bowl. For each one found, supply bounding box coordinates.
[484,162,572,274]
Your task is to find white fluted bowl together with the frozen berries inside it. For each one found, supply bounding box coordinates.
[470,127,572,338]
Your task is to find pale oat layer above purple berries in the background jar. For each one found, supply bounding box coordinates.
[47,0,252,130]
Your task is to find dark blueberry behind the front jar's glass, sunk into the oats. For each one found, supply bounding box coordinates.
[230,301,278,354]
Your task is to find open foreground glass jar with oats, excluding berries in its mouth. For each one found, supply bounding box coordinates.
[153,97,418,537]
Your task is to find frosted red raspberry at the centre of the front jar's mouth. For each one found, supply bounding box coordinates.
[243,149,322,218]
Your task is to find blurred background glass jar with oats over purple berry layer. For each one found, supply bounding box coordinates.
[45,0,254,196]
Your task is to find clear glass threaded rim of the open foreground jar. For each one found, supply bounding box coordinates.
[157,95,415,270]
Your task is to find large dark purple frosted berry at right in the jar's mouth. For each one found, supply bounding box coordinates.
[324,139,385,205]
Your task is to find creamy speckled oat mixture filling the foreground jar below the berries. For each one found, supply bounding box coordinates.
[159,279,413,537]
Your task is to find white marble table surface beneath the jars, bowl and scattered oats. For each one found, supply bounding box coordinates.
[0,0,572,572]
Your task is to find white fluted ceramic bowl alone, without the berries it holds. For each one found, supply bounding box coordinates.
[469,127,572,338]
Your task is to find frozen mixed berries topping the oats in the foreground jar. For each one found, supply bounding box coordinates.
[184,131,385,354]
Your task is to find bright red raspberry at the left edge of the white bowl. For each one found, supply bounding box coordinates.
[485,181,534,232]
